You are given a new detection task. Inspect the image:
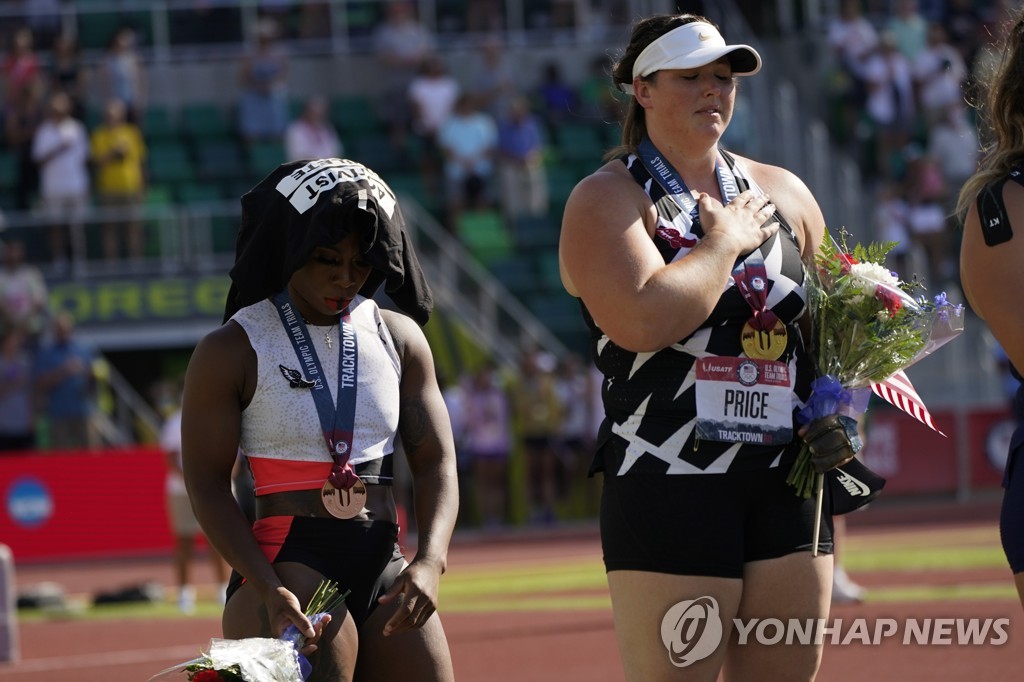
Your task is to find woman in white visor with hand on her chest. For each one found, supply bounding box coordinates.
[559,14,833,682]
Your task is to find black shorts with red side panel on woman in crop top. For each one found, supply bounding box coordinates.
[227,516,406,627]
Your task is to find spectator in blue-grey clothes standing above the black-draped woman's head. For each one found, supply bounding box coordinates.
[239,17,289,142]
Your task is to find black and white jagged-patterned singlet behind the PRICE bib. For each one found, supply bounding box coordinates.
[582,155,813,475]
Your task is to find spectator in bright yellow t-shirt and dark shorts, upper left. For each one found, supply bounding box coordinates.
[92,99,145,263]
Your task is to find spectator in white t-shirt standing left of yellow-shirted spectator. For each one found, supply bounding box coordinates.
[32,91,89,272]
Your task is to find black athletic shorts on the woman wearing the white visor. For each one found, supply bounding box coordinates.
[601,458,834,578]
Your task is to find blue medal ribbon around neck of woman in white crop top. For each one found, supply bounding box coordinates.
[273,290,359,491]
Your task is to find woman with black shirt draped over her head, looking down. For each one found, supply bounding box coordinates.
[182,159,458,682]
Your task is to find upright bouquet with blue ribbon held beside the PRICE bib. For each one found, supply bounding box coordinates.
[787,230,964,524]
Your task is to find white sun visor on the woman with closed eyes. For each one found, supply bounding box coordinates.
[625,22,761,89]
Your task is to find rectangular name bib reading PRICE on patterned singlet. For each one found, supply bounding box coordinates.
[696,357,794,445]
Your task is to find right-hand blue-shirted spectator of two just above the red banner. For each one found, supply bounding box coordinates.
[33,311,98,450]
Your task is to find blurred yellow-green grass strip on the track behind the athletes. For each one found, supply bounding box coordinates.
[20,516,1017,622]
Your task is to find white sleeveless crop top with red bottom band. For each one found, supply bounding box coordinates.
[231,296,401,495]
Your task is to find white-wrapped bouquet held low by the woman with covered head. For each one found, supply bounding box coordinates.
[150,581,348,682]
